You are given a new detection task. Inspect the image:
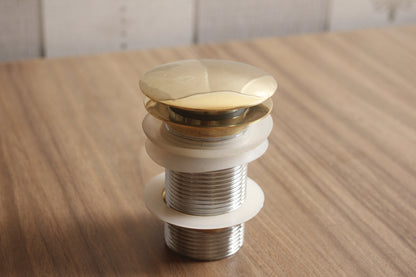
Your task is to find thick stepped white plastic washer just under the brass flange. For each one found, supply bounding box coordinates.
[143,115,273,173]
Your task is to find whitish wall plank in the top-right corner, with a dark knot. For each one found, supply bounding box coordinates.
[329,0,416,30]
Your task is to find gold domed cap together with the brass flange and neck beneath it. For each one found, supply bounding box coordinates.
[139,59,277,137]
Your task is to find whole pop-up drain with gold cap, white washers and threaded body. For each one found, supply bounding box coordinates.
[139,59,277,260]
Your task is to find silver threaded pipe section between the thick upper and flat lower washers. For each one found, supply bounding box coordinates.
[165,164,247,215]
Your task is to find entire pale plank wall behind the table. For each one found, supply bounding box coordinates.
[0,0,416,61]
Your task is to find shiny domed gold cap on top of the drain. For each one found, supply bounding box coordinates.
[139,60,277,111]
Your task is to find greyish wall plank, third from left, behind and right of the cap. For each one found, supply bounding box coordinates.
[197,0,328,43]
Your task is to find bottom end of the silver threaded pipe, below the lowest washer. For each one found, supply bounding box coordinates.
[165,223,244,260]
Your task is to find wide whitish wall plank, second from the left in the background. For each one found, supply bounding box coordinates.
[43,0,193,57]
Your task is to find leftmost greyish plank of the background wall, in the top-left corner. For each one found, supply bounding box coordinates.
[0,0,42,61]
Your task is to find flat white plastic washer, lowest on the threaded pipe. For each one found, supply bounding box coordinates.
[144,173,264,230]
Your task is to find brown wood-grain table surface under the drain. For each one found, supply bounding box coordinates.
[0,26,416,276]
